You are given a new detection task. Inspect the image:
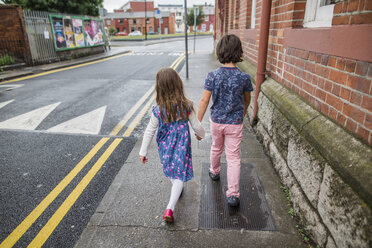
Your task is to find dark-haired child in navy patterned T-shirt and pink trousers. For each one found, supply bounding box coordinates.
[198,34,253,206]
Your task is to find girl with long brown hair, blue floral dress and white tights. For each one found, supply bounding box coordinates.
[139,68,205,223]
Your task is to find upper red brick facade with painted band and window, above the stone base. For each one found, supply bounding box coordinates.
[217,0,372,144]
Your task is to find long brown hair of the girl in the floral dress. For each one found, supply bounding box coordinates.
[155,68,194,123]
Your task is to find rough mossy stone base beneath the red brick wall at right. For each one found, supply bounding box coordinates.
[239,62,372,248]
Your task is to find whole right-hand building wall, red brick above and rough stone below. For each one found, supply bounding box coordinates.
[215,0,372,247]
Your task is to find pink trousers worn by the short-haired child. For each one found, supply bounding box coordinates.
[210,121,243,197]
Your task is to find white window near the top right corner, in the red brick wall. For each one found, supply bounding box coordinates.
[304,0,335,28]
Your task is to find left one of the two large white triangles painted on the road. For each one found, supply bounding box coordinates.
[0,102,60,130]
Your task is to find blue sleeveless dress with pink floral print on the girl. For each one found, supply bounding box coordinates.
[152,106,194,182]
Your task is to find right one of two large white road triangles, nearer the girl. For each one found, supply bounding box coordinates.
[47,106,106,134]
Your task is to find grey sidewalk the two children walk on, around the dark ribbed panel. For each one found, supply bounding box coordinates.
[75,51,305,248]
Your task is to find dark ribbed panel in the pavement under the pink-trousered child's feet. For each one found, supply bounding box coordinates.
[199,163,275,231]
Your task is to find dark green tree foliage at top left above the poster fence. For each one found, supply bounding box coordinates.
[2,0,103,16]
